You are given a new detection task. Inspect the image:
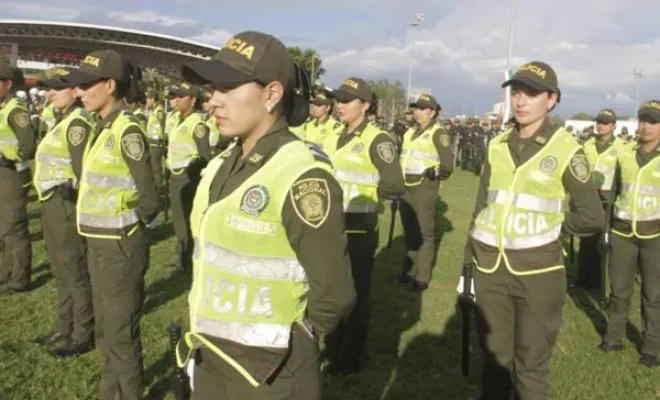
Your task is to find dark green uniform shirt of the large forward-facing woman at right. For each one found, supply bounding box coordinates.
[464,119,605,269]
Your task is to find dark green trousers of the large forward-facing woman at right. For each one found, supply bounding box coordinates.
[474,264,566,400]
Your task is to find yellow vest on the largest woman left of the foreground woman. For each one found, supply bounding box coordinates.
[77,111,140,240]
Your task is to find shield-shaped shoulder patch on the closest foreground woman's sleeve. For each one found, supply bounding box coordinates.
[289,178,331,228]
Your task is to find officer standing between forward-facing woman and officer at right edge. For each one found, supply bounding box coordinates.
[574,108,624,290]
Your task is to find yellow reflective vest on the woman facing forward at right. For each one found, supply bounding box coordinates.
[470,128,580,275]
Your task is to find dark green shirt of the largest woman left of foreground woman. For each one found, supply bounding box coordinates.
[90,103,160,223]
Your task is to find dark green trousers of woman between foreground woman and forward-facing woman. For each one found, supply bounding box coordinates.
[399,181,439,282]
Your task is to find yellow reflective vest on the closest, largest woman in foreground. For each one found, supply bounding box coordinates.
[177,141,330,387]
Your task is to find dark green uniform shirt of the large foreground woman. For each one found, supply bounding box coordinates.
[209,119,355,382]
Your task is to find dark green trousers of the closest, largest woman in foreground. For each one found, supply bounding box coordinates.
[192,326,321,400]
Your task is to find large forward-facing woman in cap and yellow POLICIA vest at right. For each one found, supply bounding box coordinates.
[465,61,604,400]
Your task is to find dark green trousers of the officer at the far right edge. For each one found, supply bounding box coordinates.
[604,233,660,357]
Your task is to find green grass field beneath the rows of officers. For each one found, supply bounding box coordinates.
[0,171,660,400]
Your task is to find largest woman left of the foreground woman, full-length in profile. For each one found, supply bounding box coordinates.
[66,50,158,400]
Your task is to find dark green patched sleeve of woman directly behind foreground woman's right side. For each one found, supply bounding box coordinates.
[369,132,406,199]
